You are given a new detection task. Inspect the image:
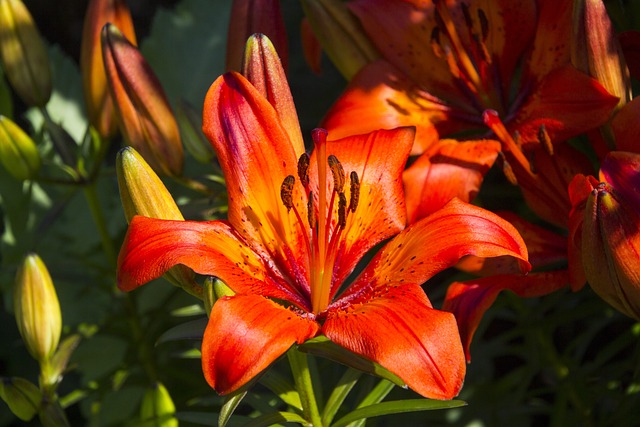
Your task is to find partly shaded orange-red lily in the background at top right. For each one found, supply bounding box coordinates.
[323,0,618,154]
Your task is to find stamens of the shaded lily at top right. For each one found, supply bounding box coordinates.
[431,0,504,113]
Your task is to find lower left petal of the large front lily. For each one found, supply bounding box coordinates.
[202,295,318,394]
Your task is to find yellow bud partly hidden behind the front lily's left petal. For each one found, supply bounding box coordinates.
[116,147,202,297]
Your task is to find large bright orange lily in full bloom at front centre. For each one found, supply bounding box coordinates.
[118,73,529,399]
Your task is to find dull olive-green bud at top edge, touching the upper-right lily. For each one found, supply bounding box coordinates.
[302,0,379,80]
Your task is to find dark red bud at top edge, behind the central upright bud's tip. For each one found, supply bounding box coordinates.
[227,0,288,71]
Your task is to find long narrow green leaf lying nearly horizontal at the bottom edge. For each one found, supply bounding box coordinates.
[331,399,467,427]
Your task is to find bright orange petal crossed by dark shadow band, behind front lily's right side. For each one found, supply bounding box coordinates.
[402,139,500,224]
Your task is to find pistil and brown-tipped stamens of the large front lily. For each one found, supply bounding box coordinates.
[280,129,360,314]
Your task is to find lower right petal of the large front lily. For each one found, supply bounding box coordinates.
[322,285,466,399]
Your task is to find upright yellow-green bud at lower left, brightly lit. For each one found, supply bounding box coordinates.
[13,254,62,363]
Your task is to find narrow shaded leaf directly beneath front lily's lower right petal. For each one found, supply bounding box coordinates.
[298,336,406,387]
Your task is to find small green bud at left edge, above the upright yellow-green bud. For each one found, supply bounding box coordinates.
[0,115,41,180]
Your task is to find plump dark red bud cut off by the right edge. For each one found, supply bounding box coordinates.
[582,183,640,320]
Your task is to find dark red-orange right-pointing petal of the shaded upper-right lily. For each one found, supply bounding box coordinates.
[508,66,618,143]
